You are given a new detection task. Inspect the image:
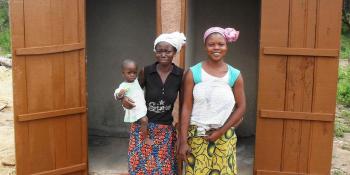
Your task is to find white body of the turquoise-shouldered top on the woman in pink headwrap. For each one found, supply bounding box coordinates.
[191,68,238,130]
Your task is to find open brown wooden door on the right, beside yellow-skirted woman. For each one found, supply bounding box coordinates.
[254,0,342,175]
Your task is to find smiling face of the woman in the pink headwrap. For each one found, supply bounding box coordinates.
[205,33,227,61]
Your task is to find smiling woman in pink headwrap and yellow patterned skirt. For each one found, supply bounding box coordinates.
[179,27,246,174]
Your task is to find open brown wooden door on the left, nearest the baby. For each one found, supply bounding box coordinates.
[10,0,87,175]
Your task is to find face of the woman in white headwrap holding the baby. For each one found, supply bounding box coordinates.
[156,42,176,65]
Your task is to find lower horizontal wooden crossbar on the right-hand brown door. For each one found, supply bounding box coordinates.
[260,110,335,122]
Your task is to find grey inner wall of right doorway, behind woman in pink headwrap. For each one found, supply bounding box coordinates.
[186,0,260,136]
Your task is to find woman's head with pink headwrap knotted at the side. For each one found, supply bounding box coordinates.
[203,27,239,61]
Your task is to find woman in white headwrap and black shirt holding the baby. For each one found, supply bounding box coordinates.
[122,32,186,175]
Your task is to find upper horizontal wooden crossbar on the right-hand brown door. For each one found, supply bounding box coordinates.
[263,47,339,58]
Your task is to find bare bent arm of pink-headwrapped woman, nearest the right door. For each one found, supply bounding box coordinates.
[207,75,246,141]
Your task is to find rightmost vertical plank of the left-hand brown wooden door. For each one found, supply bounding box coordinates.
[63,0,87,175]
